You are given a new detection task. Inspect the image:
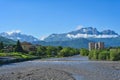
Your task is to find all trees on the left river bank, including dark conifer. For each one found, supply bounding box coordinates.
[0,40,80,57]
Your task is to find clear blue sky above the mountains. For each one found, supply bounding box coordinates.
[0,0,120,38]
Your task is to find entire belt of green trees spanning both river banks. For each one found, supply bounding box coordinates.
[0,40,120,61]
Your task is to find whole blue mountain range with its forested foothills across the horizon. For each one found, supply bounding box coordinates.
[0,27,120,48]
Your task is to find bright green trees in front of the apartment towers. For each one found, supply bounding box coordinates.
[80,48,120,61]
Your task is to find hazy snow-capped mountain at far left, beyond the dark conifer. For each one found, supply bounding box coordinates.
[0,31,38,42]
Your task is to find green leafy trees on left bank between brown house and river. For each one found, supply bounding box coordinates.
[32,46,80,57]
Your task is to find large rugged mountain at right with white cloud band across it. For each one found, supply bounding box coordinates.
[44,27,119,42]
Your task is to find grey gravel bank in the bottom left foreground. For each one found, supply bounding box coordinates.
[0,68,74,80]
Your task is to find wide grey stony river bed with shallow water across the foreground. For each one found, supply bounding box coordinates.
[0,55,120,80]
